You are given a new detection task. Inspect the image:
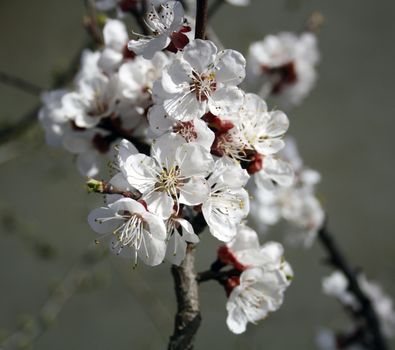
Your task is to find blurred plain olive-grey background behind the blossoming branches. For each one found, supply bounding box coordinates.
[0,0,395,350]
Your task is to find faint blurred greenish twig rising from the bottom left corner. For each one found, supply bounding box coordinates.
[0,245,106,350]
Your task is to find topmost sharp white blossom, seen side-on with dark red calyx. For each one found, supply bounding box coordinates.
[128,1,191,59]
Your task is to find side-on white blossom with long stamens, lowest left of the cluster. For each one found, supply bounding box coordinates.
[88,198,166,266]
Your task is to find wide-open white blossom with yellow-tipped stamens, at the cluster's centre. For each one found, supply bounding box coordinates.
[121,134,214,218]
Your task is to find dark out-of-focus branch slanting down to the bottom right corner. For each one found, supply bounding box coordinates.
[318,222,388,350]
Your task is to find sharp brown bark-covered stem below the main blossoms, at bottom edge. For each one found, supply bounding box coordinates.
[168,244,201,350]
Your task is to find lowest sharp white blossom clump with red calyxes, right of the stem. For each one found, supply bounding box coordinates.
[218,224,293,334]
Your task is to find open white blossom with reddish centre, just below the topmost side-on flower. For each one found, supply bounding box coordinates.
[154,39,245,121]
